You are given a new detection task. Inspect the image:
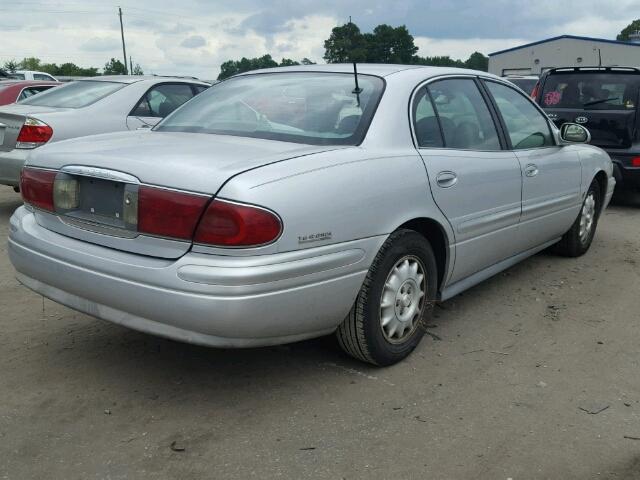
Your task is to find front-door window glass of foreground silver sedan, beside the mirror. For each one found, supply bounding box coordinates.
[485,82,555,150]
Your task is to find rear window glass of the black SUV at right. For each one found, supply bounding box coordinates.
[540,72,640,110]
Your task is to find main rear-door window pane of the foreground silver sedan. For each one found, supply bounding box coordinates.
[428,79,501,150]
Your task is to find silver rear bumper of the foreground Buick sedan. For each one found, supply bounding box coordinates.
[8,207,384,347]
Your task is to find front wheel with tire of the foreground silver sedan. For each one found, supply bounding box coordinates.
[554,180,602,257]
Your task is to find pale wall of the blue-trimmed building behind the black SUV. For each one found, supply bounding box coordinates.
[489,38,640,76]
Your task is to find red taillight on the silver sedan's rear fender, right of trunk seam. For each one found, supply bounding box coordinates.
[194,200,282,247]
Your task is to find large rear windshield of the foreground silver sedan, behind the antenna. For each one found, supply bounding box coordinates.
[154,72,384,145]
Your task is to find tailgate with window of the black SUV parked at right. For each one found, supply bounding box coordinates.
[538,69,640,149]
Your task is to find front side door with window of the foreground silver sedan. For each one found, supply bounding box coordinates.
[484,80,582,251]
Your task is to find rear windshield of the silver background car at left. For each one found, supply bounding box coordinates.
[20,80,125,108]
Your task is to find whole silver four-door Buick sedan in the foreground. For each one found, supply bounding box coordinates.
[8,65,615,365]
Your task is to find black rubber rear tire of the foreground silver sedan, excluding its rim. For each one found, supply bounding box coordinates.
[336,229,438,366]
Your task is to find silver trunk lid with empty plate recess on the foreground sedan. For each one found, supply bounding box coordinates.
[28,131,344,258]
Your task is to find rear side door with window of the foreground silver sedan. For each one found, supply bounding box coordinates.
[414,77,521,283]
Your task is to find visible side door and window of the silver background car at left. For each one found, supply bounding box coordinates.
[127,83,197,130]
